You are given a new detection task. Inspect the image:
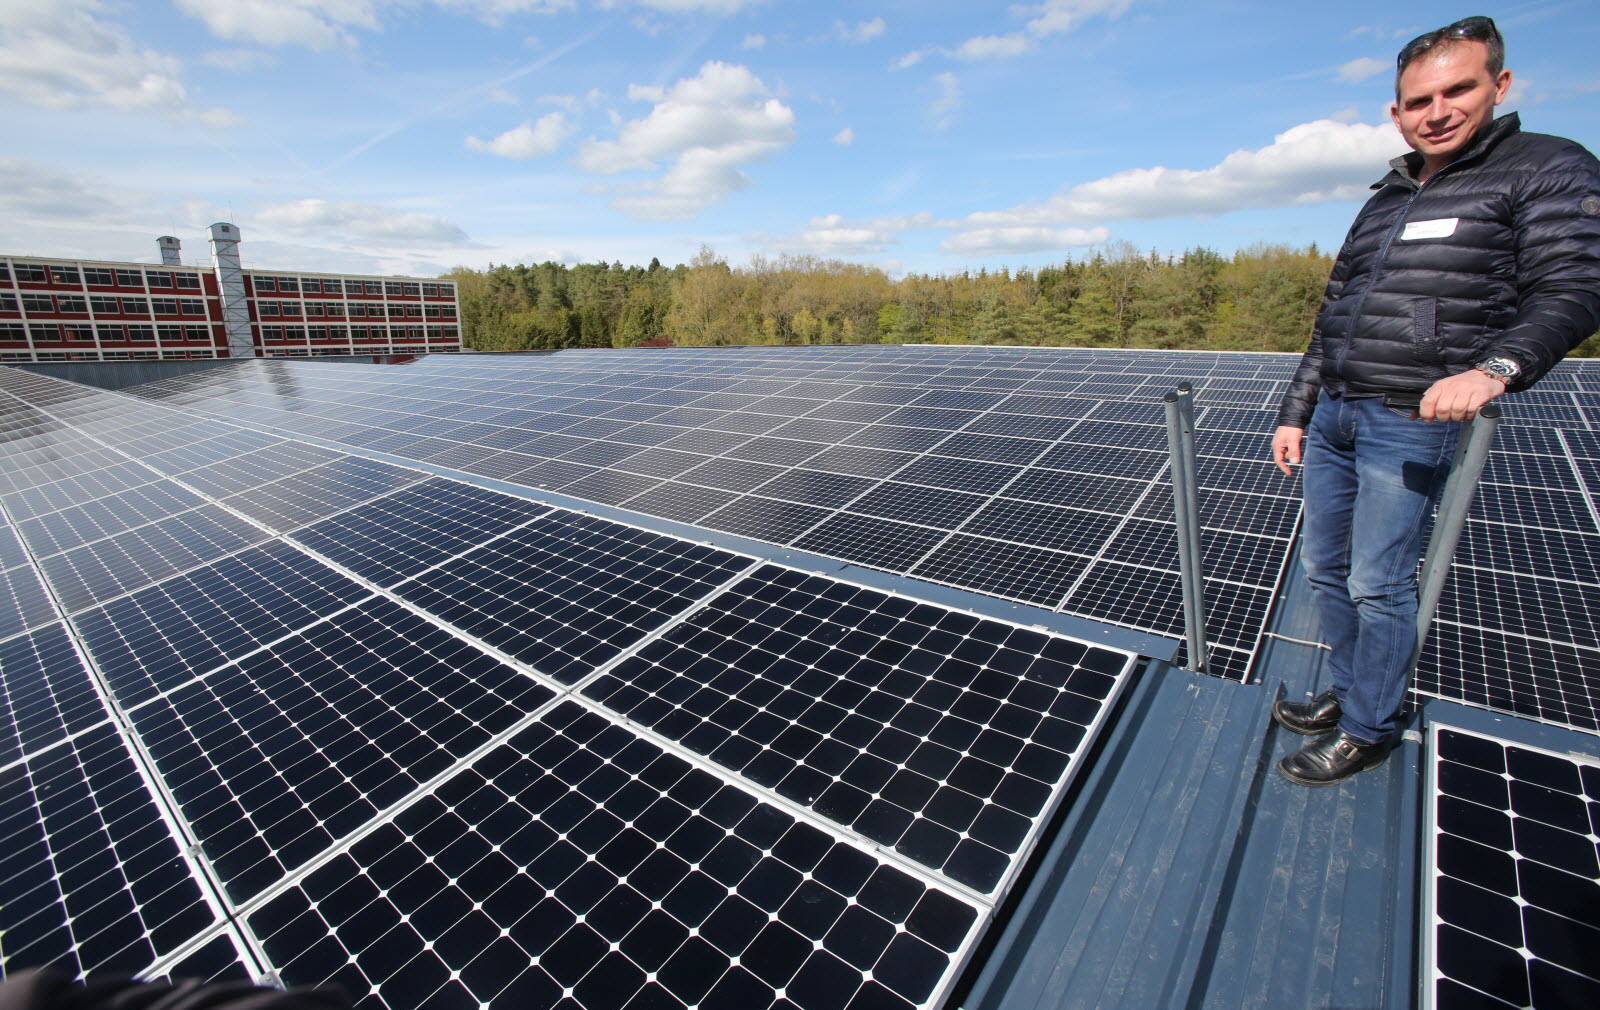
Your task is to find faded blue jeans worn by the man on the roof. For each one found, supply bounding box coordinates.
[1301,392,1461,744]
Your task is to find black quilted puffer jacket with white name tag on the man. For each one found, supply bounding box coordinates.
[1278,112,1600,427]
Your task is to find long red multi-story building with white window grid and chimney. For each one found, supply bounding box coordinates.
[0,224,461,362]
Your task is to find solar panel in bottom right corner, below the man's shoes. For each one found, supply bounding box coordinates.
[1422,725,1600,1010]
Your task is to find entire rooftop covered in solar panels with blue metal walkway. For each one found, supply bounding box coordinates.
[0,346,1600,1010]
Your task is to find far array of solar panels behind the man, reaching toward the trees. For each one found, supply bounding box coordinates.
[121,346,1600,730]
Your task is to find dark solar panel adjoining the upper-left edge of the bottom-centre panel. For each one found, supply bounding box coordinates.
[131,600,554,901]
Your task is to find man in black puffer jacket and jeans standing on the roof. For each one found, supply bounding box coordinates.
[1272,18,1600,786]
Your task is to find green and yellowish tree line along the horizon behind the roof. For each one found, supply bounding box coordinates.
[446,243,1600,355]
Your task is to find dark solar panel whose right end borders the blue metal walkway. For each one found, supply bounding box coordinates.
[584,565,1126,893]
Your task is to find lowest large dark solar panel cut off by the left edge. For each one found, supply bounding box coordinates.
[0,723,216,976]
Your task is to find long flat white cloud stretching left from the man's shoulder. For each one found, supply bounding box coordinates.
[950,120,1405,233]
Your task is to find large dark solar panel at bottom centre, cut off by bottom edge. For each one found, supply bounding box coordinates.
[248,701,979,1010]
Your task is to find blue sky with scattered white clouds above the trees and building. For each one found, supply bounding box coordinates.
[0,0,1600,275]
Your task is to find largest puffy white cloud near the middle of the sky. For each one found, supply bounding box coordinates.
[578,61,795,219]
